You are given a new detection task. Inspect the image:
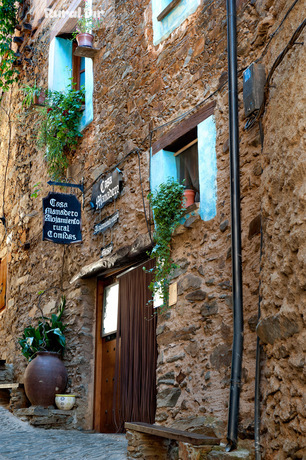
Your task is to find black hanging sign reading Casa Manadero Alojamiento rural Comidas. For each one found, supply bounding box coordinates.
[43,192,82,244]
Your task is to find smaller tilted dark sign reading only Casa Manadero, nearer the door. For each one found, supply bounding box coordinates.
[91,168,122,209]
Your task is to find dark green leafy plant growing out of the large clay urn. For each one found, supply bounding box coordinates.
[18,296,67,361]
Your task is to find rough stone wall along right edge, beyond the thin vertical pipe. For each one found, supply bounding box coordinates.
[258,1,306,460]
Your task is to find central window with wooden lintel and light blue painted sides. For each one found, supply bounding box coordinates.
[150,103,217,221]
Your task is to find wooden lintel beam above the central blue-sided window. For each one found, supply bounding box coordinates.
[152,101,216,155]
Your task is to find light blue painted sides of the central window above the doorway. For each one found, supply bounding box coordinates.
[150,115,217,221]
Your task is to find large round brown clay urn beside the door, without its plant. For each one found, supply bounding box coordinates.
[24,351,67,407]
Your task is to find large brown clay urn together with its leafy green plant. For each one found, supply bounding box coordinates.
[18,296,67,407]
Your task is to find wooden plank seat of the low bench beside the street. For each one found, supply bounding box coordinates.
[125,422,221,446]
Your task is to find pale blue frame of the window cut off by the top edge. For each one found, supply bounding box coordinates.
[152,0,201,45]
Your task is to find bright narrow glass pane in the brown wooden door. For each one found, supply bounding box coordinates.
[102,283,119,337]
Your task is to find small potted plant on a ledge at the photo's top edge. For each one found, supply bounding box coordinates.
[73,0,102,48]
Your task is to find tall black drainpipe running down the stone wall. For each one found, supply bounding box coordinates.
[226,0,243,451]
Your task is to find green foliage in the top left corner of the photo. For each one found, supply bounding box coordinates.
[0,0,22,91]
